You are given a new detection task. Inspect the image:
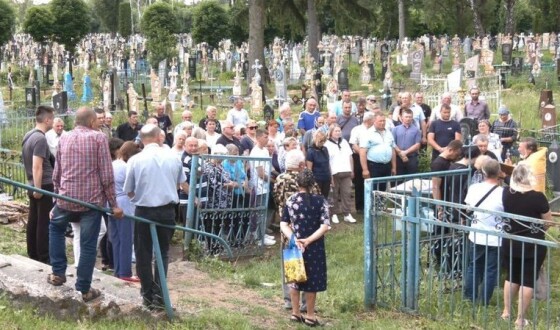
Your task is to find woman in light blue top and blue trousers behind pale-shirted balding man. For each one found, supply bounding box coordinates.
[109,141,140,282]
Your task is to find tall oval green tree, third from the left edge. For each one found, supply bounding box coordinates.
[140,2,179,68]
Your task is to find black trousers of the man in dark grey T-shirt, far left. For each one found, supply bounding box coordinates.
[26,184,54,264]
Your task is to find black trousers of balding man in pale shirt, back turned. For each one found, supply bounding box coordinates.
[134,204,175,306]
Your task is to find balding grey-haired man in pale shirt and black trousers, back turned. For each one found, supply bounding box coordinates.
[123,124,189,310]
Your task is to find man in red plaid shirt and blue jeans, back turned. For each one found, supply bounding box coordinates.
[47,107,123,302]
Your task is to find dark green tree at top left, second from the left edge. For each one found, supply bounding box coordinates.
[49,0,90,53]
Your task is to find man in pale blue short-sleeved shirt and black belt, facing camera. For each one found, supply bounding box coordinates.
[360,112,397,191]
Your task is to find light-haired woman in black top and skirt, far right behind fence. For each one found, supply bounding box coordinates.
[502,164,552,327]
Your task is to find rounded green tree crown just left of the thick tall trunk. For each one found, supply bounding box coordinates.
[192,1,229,47]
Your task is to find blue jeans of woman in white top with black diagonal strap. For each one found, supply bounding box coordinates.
[463,242,500,305]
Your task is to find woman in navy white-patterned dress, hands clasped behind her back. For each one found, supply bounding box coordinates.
[280,169,330,326]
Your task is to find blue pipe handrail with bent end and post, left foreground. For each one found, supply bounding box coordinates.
[0,176,233,319]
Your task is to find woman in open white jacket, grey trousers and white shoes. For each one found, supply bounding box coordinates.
[325,124,356,223]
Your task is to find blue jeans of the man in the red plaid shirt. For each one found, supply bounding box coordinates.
[49,206,101,293]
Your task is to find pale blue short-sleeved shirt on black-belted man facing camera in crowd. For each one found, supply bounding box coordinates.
[360,126,395,164]
